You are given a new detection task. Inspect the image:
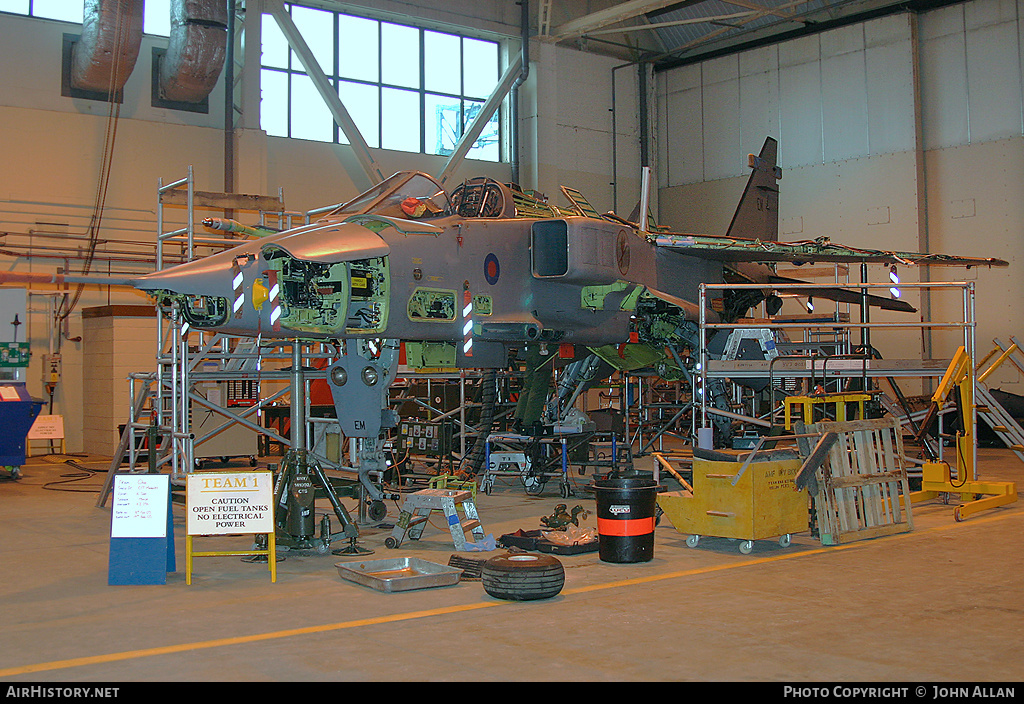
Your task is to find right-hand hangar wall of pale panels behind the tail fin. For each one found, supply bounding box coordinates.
[656,0,1024,393]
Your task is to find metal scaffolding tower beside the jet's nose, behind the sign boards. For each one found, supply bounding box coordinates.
[97,166,299,505]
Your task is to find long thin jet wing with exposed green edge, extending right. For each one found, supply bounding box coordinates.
[654,234,1009,267]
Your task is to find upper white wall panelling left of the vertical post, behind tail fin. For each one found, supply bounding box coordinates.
[659,12,937,179]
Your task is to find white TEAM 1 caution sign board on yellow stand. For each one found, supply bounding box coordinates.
[185,471,274,535]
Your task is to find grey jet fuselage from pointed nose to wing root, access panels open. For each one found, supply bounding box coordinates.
[142,195,722,367]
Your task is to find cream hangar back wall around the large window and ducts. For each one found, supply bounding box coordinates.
[0,5,638,452]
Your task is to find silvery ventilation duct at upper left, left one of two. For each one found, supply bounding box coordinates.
[70,0,145,95]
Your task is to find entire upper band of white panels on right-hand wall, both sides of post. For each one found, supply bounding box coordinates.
[660,0,1024,184]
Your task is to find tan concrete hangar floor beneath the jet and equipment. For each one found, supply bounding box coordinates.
[0,448,1024,683]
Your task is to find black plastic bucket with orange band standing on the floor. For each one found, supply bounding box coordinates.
[594,477,657,563]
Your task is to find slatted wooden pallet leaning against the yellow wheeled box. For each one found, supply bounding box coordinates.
[798,417,913,545]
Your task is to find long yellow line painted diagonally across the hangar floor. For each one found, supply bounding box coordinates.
[0,513,1020,677]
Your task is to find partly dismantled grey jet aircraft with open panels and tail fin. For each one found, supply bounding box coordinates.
[121,137,1007,438]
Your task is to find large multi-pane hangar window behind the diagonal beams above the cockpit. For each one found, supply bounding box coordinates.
[260,3,503,162]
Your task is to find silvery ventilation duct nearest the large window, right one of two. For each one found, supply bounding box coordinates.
[159,0,228,103]
